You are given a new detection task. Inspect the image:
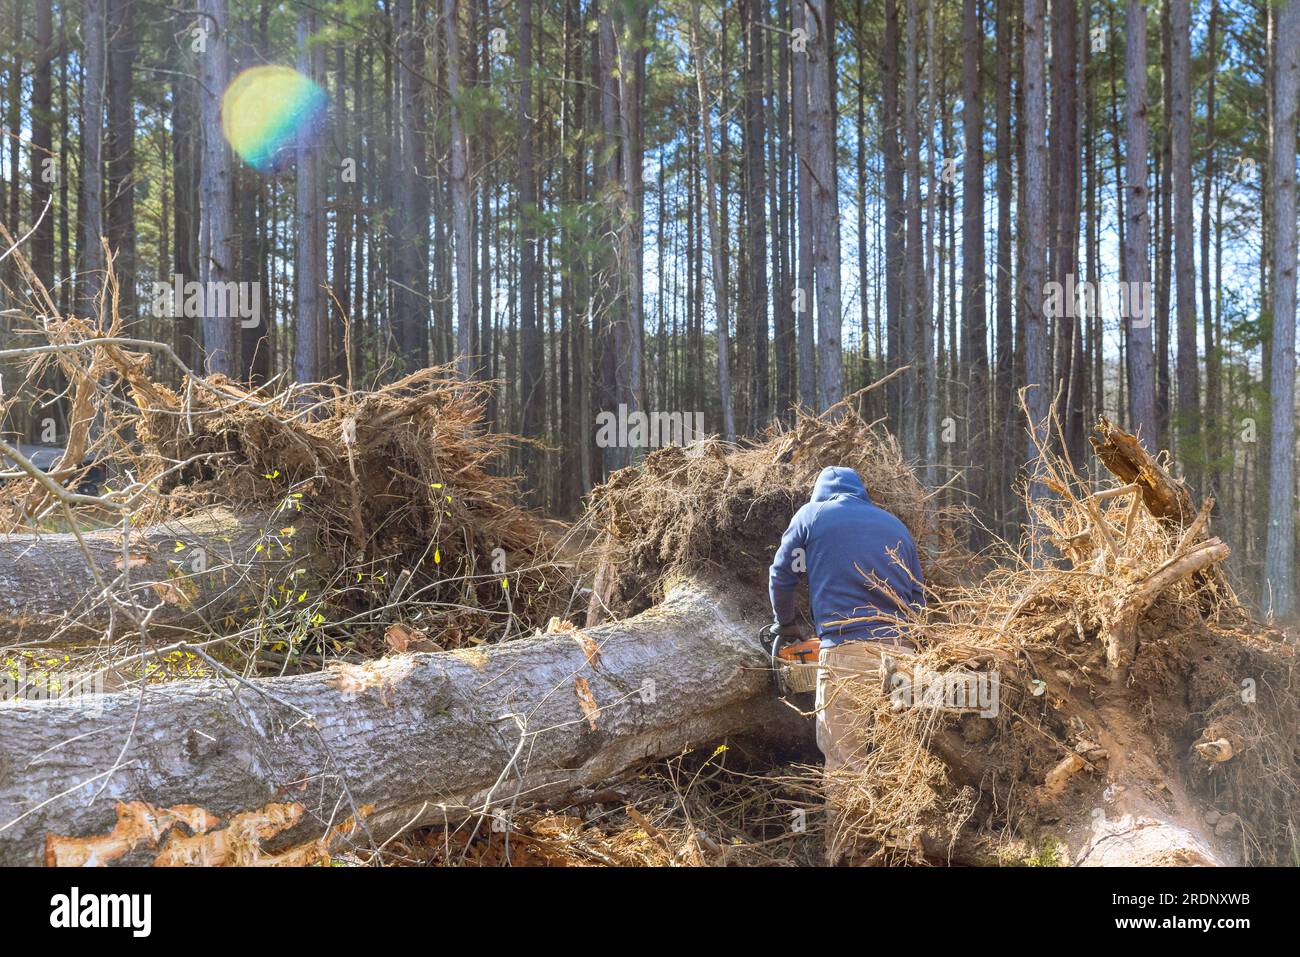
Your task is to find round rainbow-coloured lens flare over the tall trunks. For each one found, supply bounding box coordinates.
[221,66,328,173]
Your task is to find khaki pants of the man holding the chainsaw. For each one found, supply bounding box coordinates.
[816,640,915,865]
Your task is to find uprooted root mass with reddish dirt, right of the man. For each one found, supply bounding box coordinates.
[826,420,1300,865]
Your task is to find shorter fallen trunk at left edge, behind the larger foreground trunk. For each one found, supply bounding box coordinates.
[0,508,311,644]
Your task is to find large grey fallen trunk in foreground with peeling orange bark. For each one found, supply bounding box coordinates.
[0,574,807,865]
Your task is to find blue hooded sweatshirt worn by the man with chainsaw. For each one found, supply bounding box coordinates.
[767,467,926,648]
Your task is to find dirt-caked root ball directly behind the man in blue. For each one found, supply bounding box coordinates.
[584,403,971,618]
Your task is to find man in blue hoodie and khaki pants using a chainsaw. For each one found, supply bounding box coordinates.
[768,467,926,861]
